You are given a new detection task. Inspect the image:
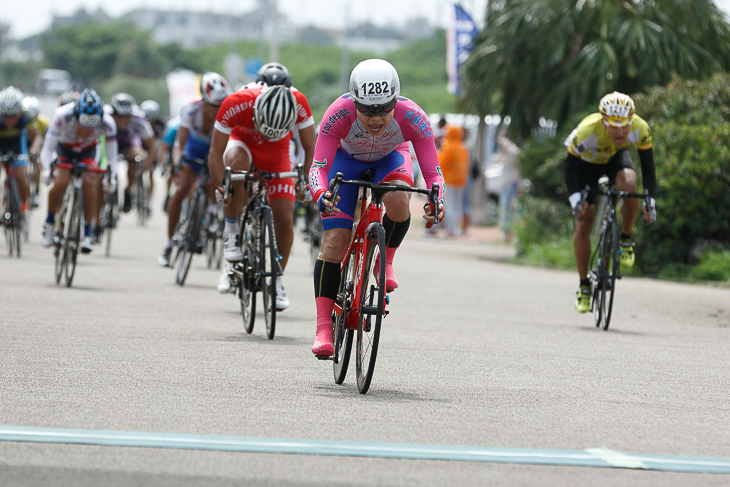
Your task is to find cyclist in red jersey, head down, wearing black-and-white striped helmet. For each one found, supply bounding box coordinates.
[208,85,314,311]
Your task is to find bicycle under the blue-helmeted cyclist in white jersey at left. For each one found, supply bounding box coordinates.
[53,163,87,287]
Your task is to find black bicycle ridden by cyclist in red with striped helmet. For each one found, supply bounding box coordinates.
[223,167,298,340]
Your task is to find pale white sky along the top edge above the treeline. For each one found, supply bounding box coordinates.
[0,0,490,39]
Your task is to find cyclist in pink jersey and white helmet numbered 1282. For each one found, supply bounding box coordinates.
[309,59,444,355]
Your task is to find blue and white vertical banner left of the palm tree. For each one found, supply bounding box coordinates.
[446,5,479,95]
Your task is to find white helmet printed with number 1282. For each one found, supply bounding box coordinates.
[350,59,400,106]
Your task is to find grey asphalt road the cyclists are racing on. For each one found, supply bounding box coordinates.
[0,180,730,486]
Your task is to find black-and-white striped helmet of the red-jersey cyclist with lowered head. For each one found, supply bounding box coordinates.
[253,85,297,140]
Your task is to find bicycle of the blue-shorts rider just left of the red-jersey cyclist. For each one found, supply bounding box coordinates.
[172,164,210,286]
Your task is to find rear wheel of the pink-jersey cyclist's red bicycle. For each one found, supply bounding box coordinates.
[332,253,355,384]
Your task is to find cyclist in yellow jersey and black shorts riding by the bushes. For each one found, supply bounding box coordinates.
[563,91,656,313]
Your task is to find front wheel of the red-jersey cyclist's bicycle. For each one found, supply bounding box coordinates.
[259,207,279,340]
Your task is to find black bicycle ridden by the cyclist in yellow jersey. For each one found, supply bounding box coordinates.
[581,177,649,330]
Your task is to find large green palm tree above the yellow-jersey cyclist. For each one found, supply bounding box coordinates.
[462,0,730,135]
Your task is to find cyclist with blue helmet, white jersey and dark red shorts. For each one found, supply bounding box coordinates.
[41,88,117,253]
